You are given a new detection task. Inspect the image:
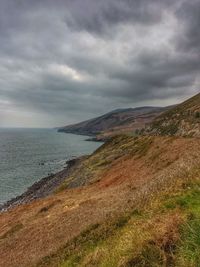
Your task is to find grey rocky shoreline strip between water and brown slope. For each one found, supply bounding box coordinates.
[0,155,87,213]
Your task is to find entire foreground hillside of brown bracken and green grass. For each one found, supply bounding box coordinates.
[0,135,200,267]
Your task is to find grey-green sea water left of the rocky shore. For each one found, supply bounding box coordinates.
[0,129,101,204]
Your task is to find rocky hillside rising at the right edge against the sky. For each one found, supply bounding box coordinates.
[146,93,200,137]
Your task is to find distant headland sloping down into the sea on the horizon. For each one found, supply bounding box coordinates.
[58,106,169,136]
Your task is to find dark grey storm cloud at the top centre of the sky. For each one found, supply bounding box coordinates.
[66,0,173,34]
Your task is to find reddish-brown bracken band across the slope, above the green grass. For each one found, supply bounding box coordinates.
[0,136,200,267]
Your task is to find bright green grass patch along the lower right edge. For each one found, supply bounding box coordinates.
[161,183,200,267]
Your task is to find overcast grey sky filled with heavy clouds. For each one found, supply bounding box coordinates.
[0,0,200,127]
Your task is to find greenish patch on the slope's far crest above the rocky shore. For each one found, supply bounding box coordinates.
[57,135,153,192]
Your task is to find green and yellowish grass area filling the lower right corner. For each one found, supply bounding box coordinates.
[37,168,200,267]
